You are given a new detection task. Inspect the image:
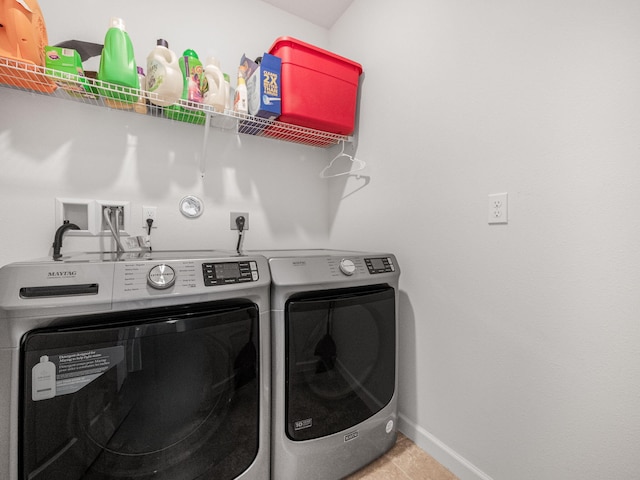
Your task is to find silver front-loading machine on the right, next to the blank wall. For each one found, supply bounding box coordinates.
[260,250,400,480]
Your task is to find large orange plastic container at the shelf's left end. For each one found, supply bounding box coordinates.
[0,0,56,93]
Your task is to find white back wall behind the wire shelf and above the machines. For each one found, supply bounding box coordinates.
[0,0,331,265]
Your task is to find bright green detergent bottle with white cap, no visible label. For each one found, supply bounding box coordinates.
[97,17,140,108]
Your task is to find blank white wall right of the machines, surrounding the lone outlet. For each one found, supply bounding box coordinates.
[330,0,640,480]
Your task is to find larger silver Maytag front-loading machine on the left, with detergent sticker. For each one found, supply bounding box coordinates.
[0,251,271,480]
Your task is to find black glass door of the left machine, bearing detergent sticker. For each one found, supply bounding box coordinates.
[20,302,259,480]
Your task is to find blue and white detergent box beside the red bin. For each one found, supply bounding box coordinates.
[247,53,282,120]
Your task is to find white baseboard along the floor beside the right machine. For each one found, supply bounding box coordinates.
[398,414,493,480]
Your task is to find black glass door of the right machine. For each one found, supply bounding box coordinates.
[285,285,396,440]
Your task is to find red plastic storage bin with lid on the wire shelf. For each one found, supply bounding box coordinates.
[269,37,362,135]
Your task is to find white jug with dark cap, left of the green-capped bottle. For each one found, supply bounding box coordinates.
[147,38,183,107]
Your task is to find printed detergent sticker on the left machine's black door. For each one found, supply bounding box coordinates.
[32,345,124,401]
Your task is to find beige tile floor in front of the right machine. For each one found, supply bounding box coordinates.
[345,433,458,480]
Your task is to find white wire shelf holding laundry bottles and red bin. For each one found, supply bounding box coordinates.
[0,57,352,147]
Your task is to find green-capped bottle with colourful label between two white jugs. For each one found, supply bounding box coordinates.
[164,49,206,125]
